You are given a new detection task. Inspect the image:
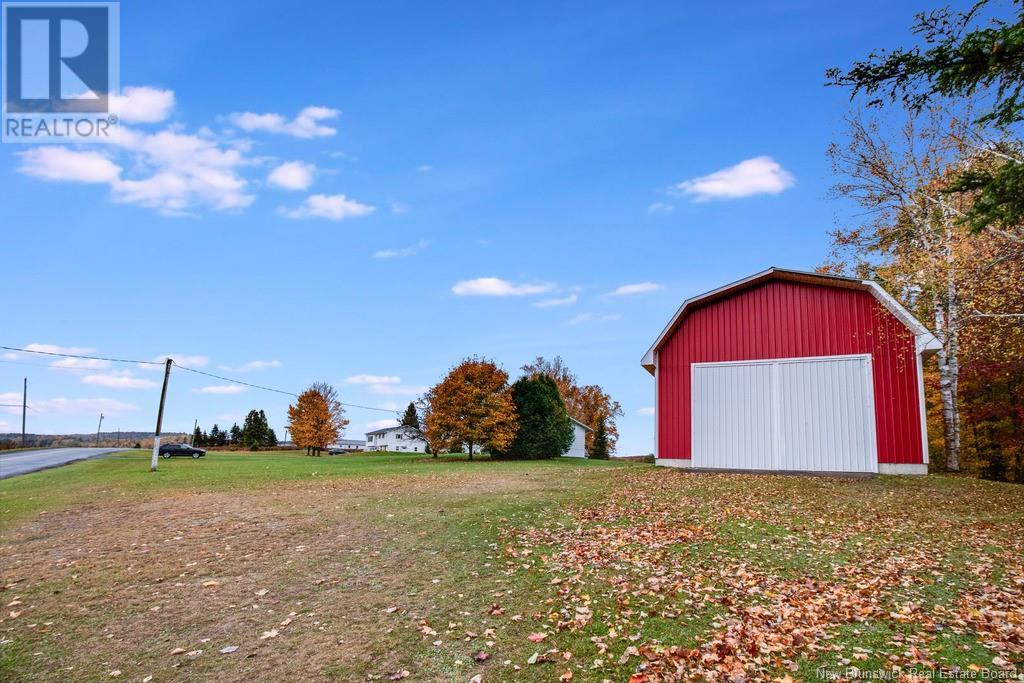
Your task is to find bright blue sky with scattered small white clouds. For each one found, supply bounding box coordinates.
[0,1,950,454]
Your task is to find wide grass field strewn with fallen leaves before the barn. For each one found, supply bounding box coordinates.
[0,453,1024,681]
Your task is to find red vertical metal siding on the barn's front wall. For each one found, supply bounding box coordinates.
[657,281,924,464]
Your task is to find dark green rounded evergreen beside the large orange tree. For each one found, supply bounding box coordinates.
[492,374,572,460]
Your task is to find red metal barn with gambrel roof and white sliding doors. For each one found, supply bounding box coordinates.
[643,268,939,474]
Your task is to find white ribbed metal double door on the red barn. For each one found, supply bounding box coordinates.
[691,355,879,472]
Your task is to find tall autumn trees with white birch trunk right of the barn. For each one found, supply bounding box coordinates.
[823,0,1024,482]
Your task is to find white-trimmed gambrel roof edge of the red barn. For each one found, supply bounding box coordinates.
[640,266,941,375]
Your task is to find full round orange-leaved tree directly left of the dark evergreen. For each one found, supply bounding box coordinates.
[423,356,517,460]
